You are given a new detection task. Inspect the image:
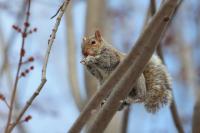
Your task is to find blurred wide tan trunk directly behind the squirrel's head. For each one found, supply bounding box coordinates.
[84,0,106,99]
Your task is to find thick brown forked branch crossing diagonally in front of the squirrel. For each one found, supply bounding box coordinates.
[69,0,180,133]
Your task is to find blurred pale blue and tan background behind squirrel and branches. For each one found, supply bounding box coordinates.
[0,0,200,133]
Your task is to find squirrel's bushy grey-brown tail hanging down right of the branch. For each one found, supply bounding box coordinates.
[144,56,172,113]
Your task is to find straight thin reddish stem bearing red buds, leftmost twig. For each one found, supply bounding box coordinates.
[5,0,31,133]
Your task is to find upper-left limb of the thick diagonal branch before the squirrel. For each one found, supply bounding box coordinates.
[69,0,181,133]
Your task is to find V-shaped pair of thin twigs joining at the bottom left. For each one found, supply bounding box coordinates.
[5,0,70,133]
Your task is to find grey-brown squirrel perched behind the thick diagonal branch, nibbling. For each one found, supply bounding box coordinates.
[81,30,172,113]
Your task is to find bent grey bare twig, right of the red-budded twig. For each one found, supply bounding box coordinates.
[5,0,70,133]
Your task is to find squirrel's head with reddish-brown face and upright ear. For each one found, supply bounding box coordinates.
[82,30,103,57]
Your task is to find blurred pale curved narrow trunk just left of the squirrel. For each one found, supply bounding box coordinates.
[65,2,86,111]
